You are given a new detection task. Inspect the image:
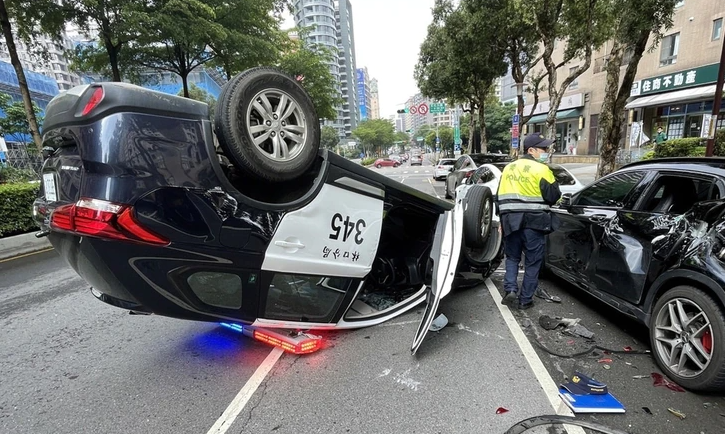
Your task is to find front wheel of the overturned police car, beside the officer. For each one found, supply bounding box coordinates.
[463,185,494,248]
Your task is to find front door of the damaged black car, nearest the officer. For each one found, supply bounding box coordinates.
[546,170,647,288]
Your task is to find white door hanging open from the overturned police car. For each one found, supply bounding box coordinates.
[410,195,463,354]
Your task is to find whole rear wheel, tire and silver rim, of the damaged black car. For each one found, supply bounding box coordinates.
[650,286,725,391]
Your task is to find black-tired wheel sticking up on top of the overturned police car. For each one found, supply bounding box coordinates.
[214,68,320,182]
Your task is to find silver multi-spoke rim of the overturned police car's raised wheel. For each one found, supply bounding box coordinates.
[246,89,307,161]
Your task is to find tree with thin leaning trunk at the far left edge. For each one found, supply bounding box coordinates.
[0,0,64,151]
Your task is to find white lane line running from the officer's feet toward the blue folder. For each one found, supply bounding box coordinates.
[486,279,585,434]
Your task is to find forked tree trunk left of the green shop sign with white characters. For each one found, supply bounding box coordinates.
[597,30,650,178]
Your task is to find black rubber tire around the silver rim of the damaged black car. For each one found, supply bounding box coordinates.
[649,286,725,392]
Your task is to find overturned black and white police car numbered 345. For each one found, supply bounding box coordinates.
[34,68,498,352]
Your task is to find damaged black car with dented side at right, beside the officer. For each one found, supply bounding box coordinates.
[546,158,725,391]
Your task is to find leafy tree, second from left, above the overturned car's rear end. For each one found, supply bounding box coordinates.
[60,0,153,81]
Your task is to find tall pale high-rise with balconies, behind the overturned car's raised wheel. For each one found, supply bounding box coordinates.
[293,0,360,137]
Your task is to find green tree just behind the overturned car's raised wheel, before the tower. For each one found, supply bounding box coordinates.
[278,38,342,119]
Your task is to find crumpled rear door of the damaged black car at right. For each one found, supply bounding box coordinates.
[592,171,723,304]
